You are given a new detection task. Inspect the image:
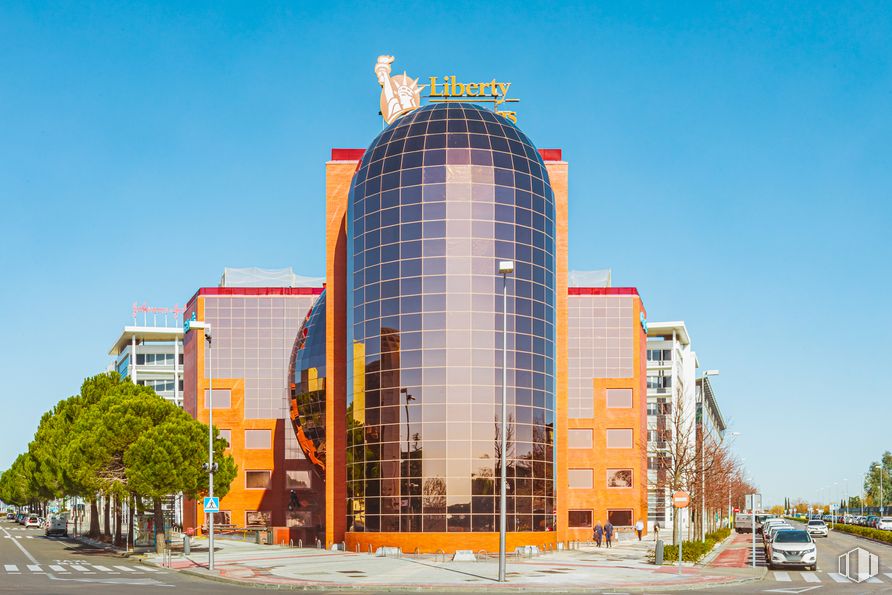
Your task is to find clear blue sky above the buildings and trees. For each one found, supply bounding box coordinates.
[0,1,892,502]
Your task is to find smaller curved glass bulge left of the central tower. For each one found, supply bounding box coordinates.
[288,291,325,470]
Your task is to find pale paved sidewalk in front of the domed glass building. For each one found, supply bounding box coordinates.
[143,539,764,592]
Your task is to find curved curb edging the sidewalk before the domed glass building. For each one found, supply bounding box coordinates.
[146,560,767,593]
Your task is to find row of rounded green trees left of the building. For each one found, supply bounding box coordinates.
[0,372,237,544]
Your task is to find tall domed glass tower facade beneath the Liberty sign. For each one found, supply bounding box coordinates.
[347,103,555,532]
